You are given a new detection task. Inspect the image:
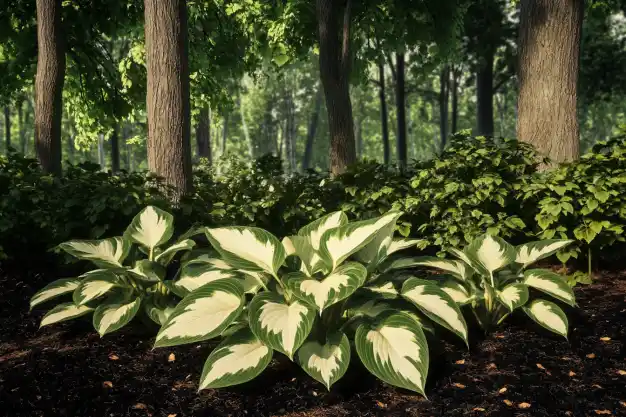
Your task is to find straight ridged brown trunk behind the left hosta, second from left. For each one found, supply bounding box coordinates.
[144,0,193,203]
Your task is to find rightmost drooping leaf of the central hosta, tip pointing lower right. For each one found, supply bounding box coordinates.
[402,278,468,344]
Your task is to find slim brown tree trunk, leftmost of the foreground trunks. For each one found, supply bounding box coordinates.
[35,0,65,175]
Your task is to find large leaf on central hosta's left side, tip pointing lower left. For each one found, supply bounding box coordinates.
[154,279,244,348]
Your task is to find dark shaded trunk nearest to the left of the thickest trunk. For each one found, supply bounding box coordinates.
[476,51,494,136]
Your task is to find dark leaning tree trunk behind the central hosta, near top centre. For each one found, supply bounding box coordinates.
[316,0,356,175]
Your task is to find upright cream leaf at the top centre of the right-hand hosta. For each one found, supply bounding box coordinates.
[465,234,516,286]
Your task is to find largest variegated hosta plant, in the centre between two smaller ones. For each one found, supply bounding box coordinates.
[155,212,467,394]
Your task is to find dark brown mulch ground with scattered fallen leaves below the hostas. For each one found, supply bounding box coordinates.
[0,273,626,417]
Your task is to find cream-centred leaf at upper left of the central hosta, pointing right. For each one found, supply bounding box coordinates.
[206,226,286,275]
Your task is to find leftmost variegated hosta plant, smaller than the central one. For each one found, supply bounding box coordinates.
[30,206,195,336]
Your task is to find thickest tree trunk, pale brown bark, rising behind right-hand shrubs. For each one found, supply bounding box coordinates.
[517,0,584,163]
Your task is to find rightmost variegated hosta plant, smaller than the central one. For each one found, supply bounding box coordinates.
[388,234,576,338]
